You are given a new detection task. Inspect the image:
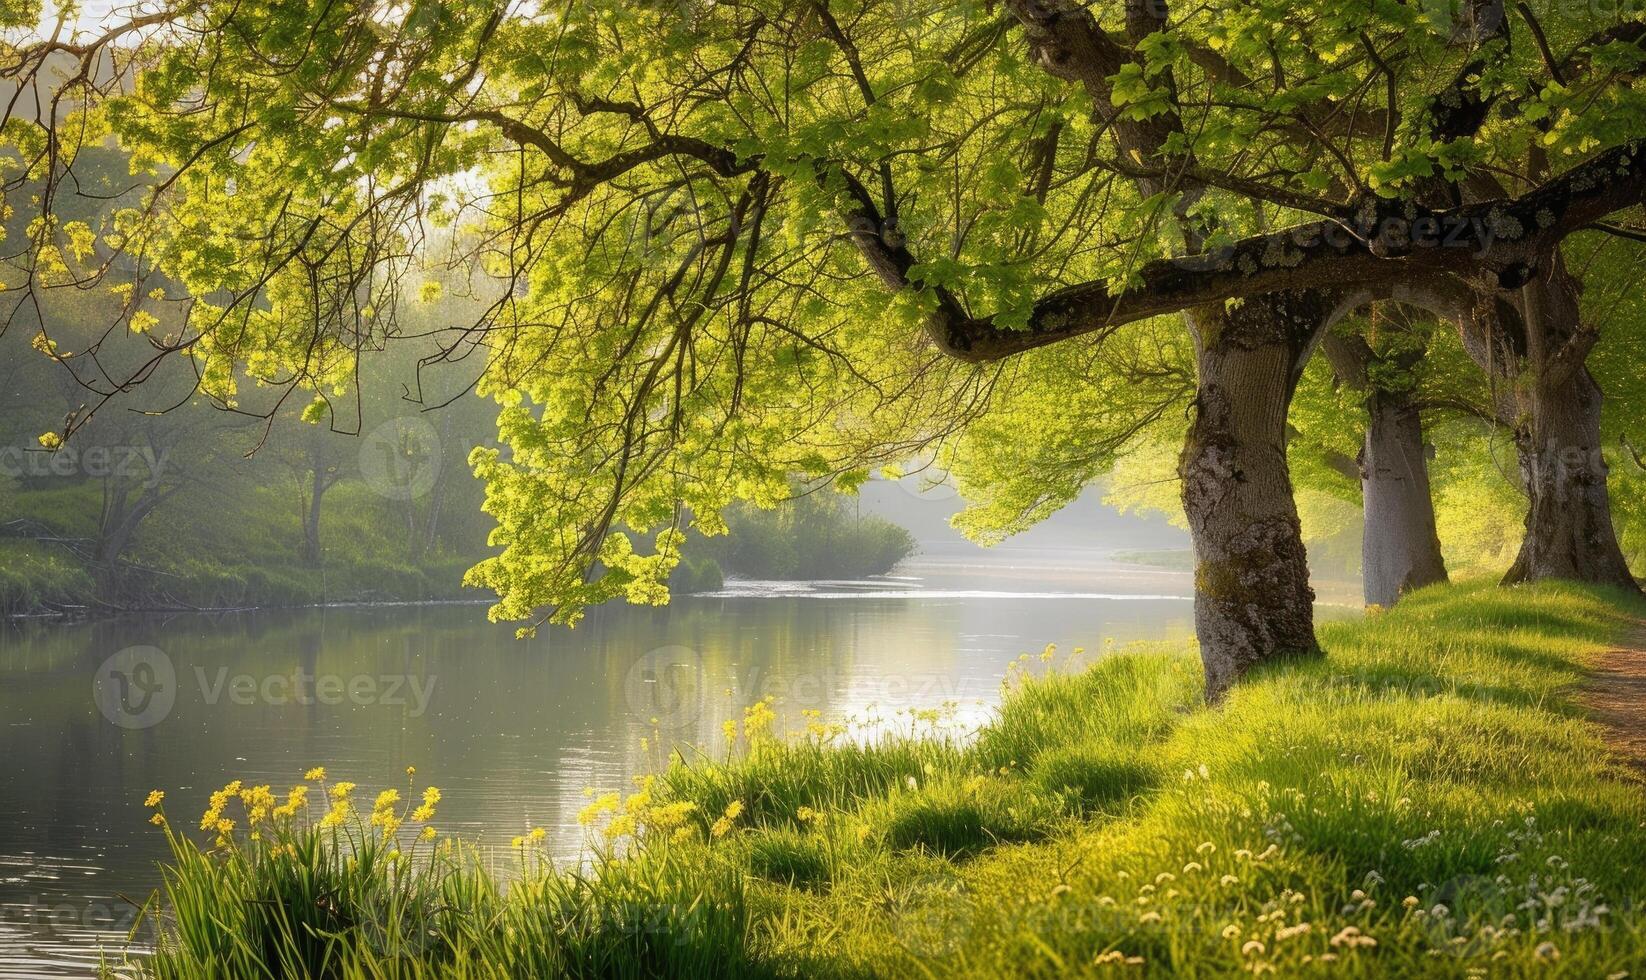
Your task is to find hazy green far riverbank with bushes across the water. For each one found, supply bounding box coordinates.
[0,478,915,619]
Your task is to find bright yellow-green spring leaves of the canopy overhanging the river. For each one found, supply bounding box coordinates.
[3,0,1646,621]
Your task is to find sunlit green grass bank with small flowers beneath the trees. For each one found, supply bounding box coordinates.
[119,585,1646,978]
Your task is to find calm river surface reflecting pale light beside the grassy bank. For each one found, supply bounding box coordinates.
[0,563,1356,977]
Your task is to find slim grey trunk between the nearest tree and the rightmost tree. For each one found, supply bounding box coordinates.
[1360,392,1447,608]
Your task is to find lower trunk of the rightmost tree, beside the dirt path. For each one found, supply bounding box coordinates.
[1503,366,1636,588]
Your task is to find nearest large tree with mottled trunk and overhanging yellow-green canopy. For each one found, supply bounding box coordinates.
[7,0,1646,698]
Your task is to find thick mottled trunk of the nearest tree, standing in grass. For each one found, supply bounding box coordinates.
[1179,293,1328,702]
